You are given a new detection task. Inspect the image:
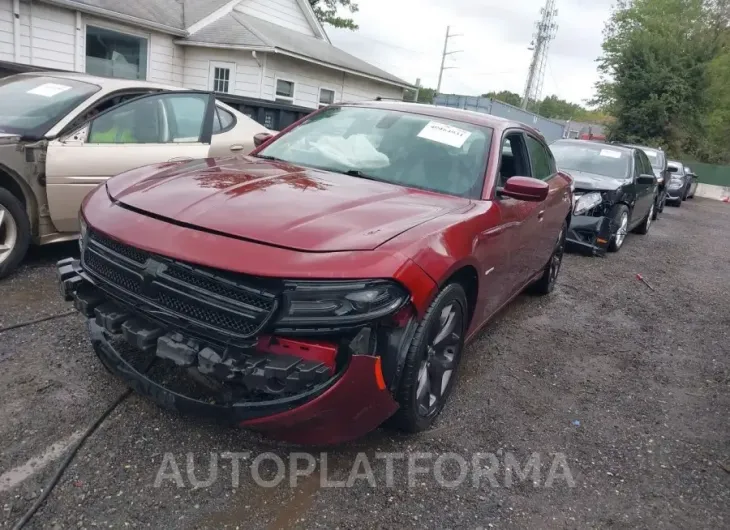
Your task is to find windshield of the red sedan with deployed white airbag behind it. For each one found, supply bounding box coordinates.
[258,106,492,197]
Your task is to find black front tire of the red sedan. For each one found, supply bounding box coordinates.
[385,283,468,433]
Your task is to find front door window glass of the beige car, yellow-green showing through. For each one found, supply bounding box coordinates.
[87,94,208,144]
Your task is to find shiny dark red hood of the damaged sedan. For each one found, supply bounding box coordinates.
[107,157,469,252]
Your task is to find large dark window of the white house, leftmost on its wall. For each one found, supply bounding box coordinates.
[86,26,149,79]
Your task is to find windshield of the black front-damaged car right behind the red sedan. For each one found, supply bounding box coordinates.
[550,142,631,179]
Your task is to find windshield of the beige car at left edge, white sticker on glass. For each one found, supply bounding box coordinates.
[0,75,100,137]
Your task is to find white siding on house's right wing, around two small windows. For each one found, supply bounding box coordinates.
[262,54,403,108]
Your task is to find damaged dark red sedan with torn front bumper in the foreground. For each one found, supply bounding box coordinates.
[58,101,572,444]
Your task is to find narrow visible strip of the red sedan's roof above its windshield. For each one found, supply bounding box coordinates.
[342,100,544,138]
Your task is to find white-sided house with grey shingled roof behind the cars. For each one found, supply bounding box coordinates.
[0,0,411,108]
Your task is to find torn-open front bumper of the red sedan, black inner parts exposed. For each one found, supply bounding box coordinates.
[57,259,400,444]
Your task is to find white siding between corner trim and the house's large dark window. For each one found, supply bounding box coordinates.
[18,2,76,70]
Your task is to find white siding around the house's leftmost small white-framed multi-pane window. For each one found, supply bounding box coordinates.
[183,47,261,98]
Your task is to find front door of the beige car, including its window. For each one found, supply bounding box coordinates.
[46,91,215,232]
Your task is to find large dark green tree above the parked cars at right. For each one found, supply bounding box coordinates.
[595,0,726,156]
